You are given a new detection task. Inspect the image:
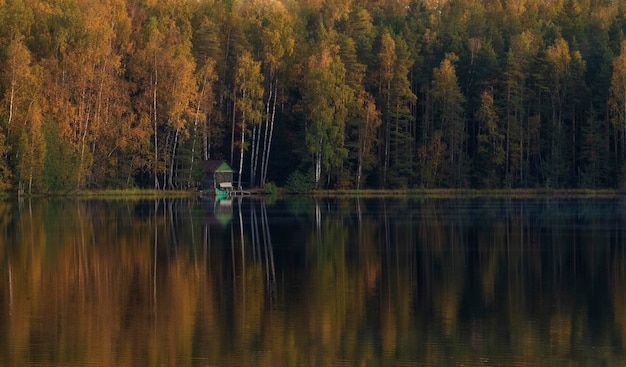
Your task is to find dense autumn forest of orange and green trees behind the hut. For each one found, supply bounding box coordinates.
[0,0,626,193]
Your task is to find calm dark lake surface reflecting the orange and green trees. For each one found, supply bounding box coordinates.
[0,198,626,366]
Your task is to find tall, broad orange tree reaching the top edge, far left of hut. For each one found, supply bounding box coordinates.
[59,1,128,188]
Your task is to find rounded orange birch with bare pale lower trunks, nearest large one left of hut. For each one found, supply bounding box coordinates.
[134,17,197,188]
